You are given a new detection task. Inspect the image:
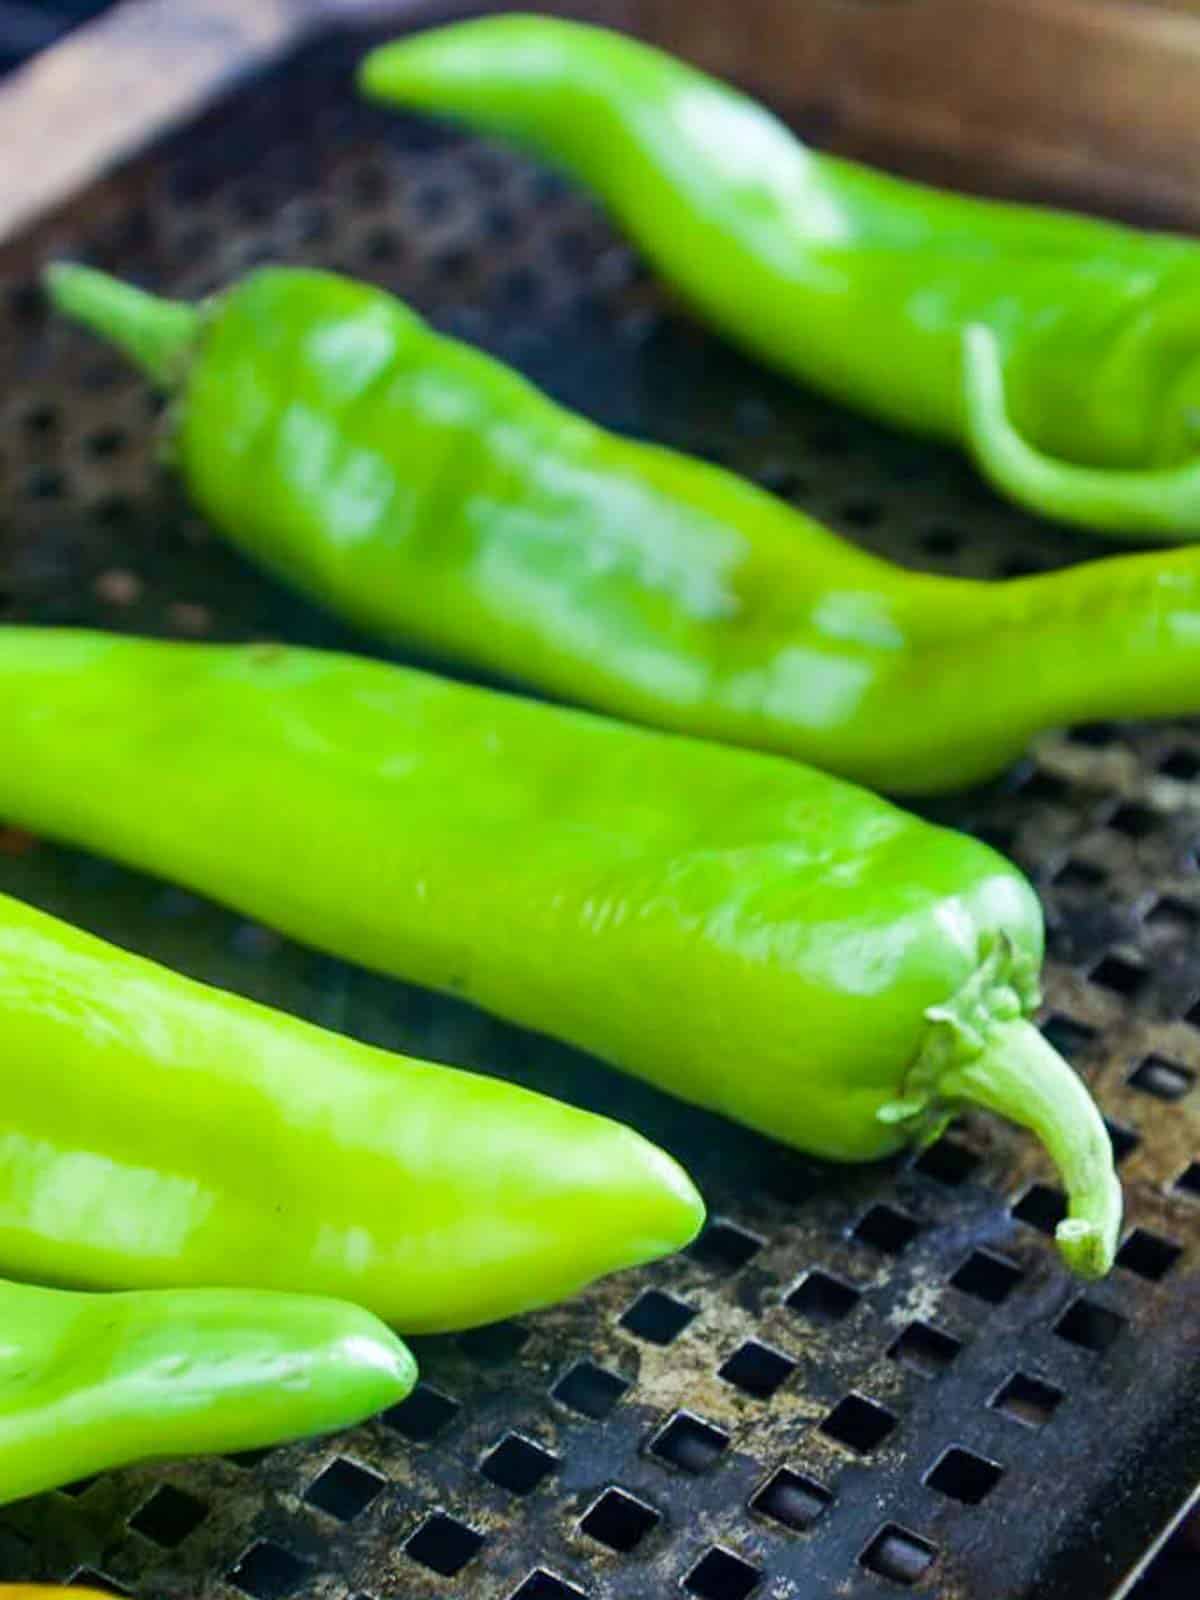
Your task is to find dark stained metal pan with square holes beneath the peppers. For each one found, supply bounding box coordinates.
[0,15,1200,1600]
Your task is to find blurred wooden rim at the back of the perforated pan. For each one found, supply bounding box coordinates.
[0,0,1200,246]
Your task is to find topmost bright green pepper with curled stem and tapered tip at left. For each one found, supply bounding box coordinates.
[360,16,1200,539]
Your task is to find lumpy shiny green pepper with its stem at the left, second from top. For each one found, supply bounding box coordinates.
[50,266,1200,794]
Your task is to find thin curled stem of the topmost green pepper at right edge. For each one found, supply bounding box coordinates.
[963,323,1200,541]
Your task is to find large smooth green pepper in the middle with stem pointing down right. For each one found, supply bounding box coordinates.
[0,626,1122,1278]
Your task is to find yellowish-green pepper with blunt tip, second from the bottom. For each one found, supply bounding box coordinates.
[0,876,702,1333]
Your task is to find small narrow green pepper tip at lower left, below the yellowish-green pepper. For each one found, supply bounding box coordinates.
[0,1282,416,1497]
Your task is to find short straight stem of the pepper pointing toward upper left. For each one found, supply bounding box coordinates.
[43,261,200,389]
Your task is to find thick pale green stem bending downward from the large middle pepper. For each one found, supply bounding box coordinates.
[938,1019,1122,1278]
